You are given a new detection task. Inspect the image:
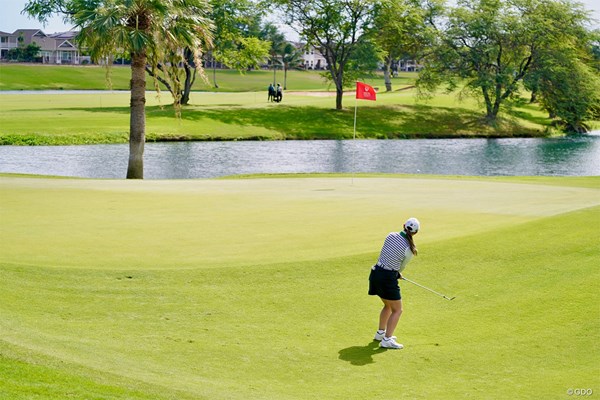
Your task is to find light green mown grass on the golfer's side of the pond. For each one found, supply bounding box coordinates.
[0,176,600,400]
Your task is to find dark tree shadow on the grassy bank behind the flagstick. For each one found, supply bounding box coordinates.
[182,105,541,139]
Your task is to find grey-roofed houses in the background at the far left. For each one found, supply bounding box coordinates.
[0,29,90,64]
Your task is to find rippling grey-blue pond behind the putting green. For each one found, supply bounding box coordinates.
[0,132,600,179]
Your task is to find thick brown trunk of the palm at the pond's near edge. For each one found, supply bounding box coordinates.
[127,51,146,179]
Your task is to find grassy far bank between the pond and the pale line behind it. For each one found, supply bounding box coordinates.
[0,89,549,145]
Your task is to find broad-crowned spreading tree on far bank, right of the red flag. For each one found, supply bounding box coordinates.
[417,0,588,124]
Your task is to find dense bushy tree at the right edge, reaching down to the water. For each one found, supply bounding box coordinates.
[524,2,600,132]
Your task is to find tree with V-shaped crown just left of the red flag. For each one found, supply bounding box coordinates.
[275,0,374,110]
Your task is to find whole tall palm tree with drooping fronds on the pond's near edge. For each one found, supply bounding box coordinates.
[24,0,212,179]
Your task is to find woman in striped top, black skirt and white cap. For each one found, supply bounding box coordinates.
[369,218,420,349]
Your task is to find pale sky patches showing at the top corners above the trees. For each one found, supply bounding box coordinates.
[0,0,600,34]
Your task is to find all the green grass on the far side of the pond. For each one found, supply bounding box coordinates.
[0,64,598,145]
